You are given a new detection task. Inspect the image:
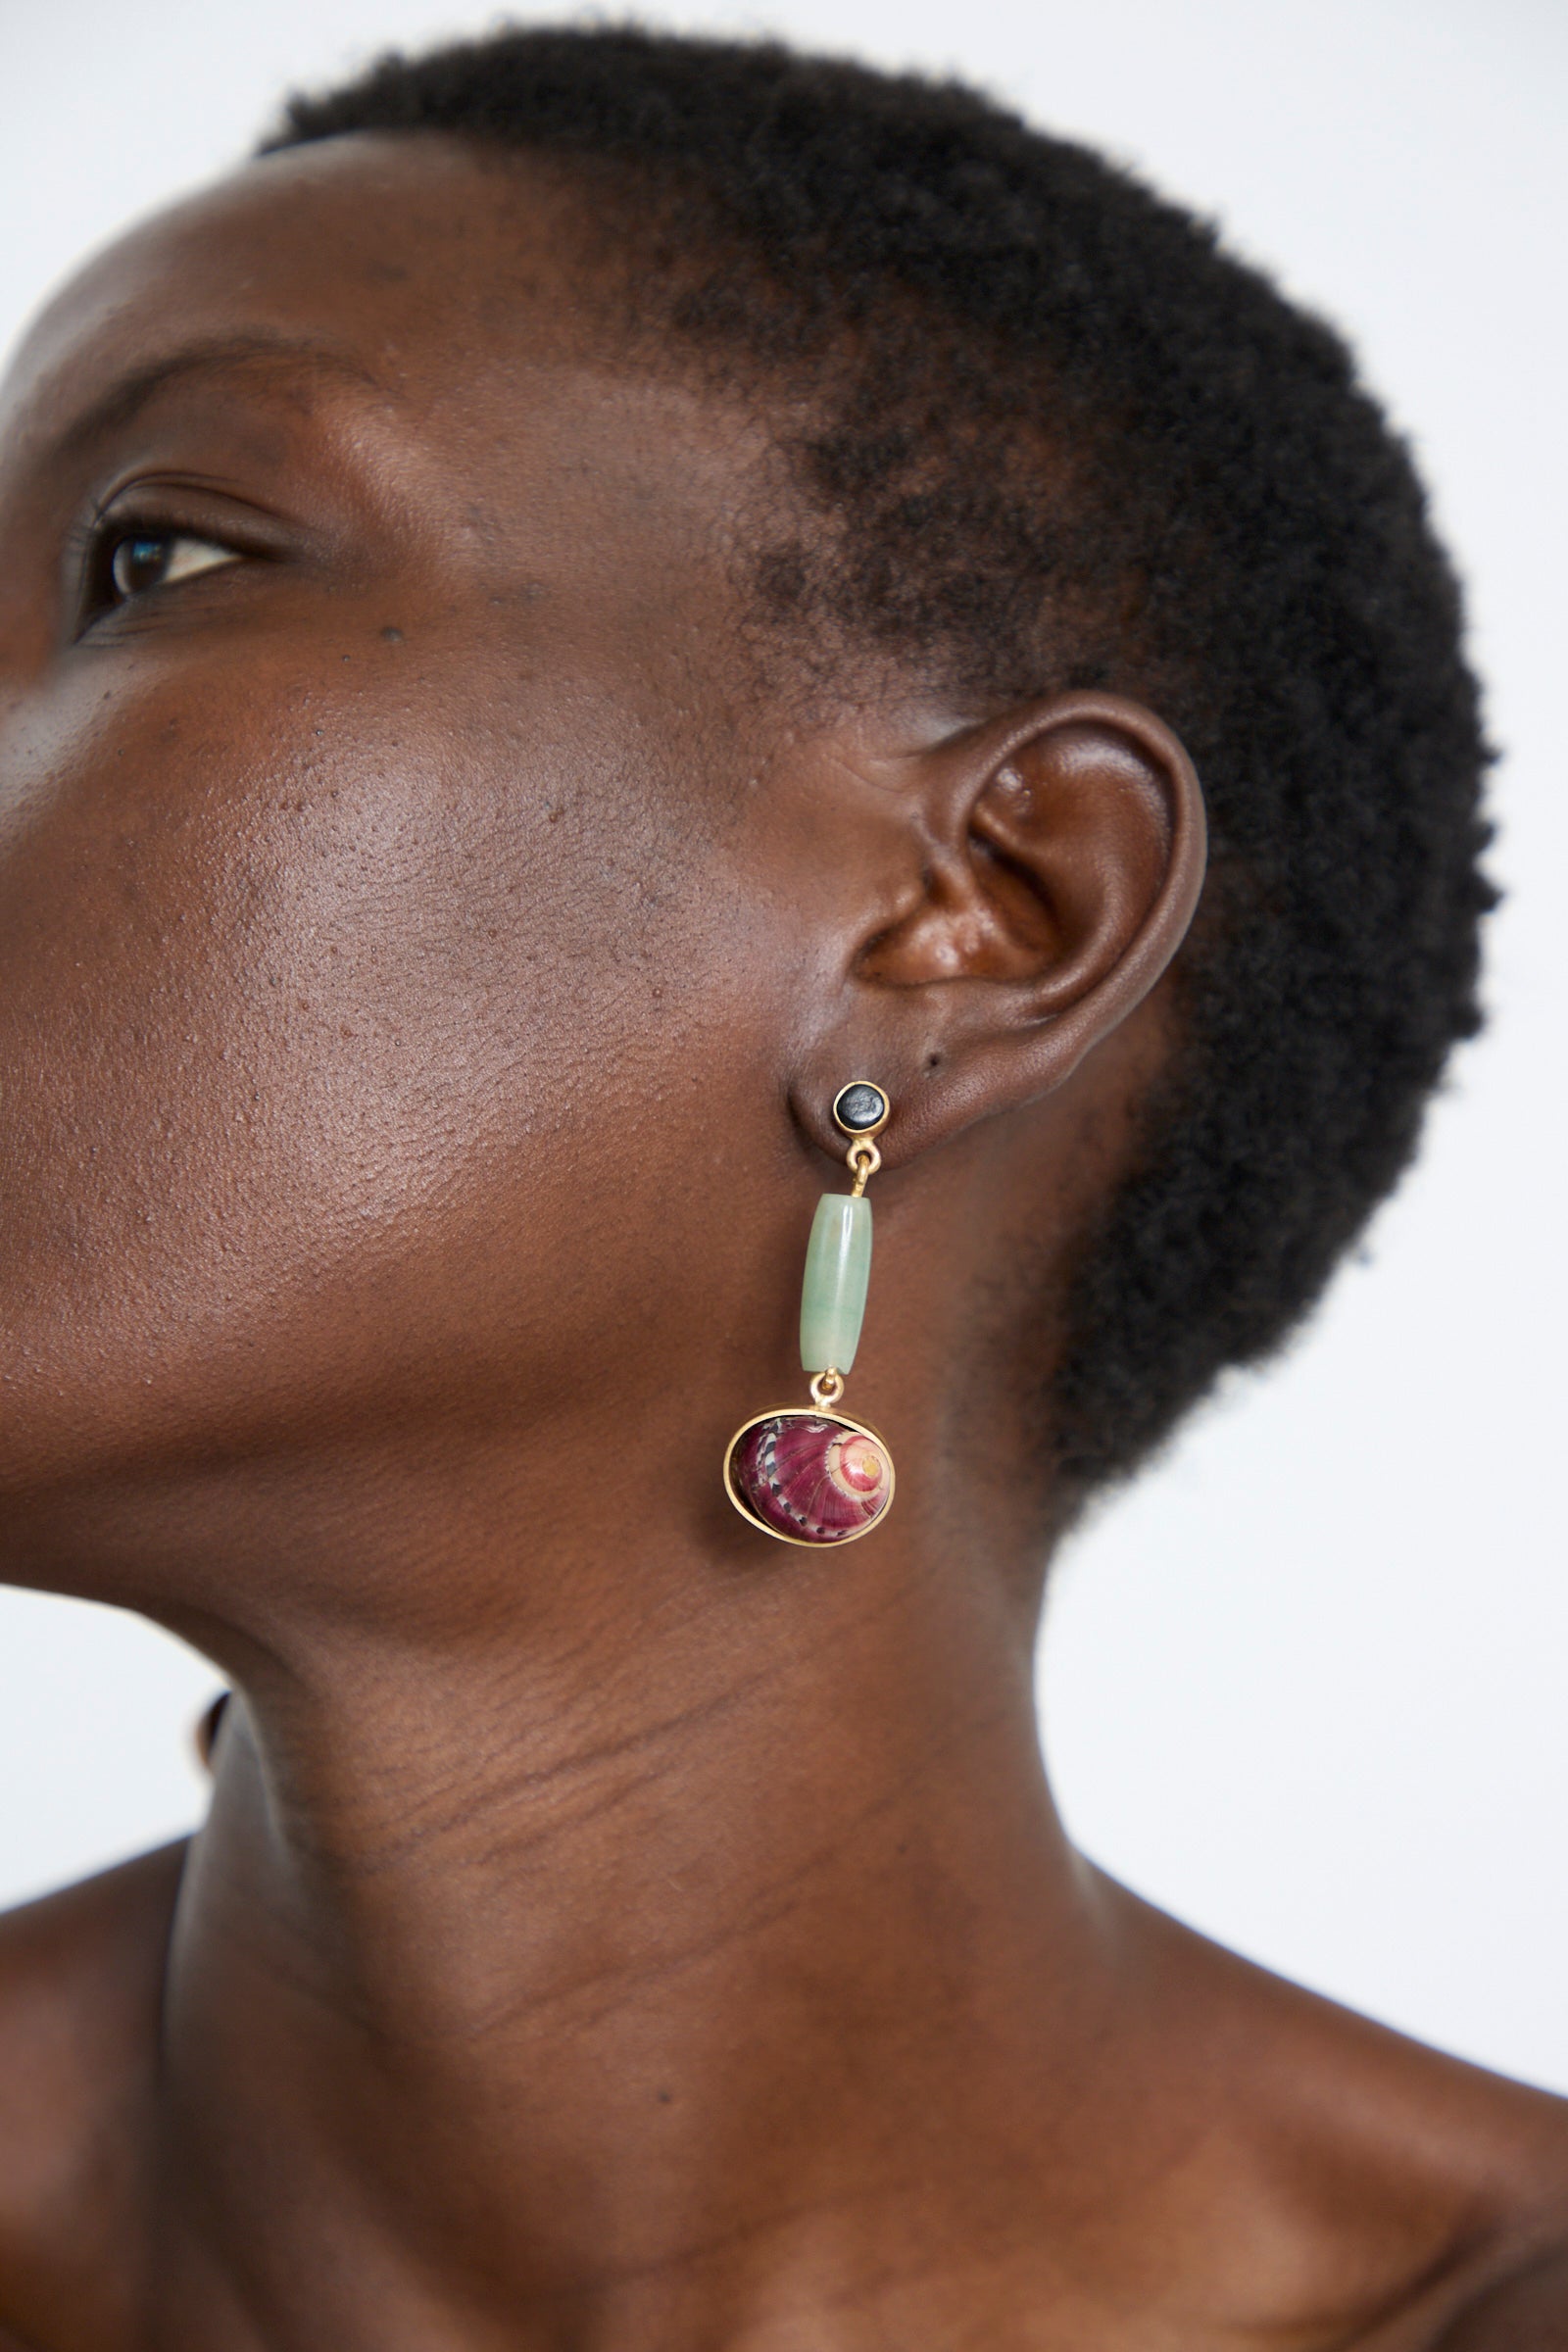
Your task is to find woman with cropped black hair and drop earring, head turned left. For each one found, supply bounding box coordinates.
[0,33,1568,2352]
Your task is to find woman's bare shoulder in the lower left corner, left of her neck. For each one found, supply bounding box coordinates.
[0,1841,186,2352]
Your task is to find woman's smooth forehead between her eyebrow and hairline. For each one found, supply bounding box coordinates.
[0,134,768,588]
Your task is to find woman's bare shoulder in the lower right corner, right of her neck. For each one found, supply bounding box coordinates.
[1114,1888,1568,2352]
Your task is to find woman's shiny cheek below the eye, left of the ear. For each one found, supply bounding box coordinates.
[0,649,766,1477]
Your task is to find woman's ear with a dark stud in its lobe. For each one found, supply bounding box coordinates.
[795,694,1206,1164]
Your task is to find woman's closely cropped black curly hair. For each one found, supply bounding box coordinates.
[270,28,1493,1494]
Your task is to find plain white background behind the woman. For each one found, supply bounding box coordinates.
[0,0,1568,2091]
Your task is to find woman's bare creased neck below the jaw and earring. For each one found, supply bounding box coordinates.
[160,1458,1128,2352]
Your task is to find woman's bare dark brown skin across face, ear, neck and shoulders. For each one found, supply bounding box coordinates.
[0,139,1568,2352]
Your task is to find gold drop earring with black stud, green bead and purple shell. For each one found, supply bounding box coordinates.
[724,1077,894,1545]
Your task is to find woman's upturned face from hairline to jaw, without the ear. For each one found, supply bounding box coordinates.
[0,139,874,1586]
